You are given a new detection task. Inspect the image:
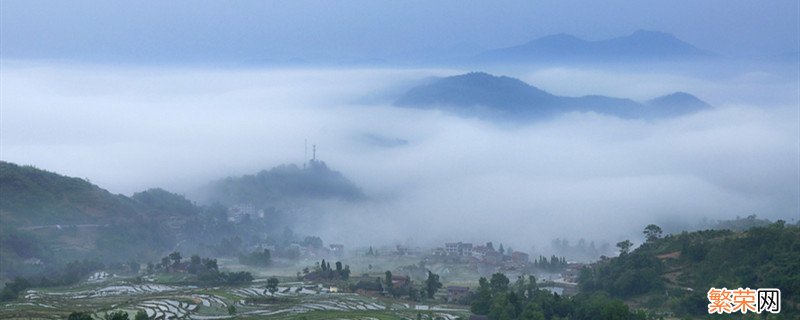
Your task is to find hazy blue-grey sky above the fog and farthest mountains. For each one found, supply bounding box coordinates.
[0,0,800,63]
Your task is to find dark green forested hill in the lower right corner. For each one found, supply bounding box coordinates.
[579,221,800,318]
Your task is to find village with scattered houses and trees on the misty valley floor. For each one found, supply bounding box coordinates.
[233,238,585,305]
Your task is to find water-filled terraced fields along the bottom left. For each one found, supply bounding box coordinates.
[0,279,469,320]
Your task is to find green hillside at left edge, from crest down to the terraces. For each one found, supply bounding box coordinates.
[0,161,207,279]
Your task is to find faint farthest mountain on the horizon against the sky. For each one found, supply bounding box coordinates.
[474,30,713,63]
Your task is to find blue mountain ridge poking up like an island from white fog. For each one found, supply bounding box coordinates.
[395,72,711,121]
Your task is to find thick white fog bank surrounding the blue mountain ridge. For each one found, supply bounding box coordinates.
[0,63,800,250]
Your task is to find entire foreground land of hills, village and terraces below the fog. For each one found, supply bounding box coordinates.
[0,154,800,319]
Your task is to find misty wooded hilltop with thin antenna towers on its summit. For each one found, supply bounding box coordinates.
[205,159,365,208]
